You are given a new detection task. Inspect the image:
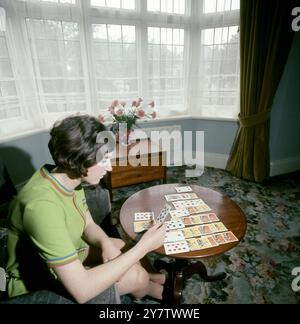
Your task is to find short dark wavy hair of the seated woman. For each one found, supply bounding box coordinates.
[48,115,113,179]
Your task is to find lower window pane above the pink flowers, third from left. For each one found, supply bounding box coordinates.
[93,24,139,107]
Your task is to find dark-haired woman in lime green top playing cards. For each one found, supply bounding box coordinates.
[7,116,166,303]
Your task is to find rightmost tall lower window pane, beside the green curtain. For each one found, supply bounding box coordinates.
[200,26,239,117]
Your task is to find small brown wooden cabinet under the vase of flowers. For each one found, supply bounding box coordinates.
[107,140,166,199]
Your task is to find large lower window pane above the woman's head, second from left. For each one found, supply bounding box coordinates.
[26,19,87,113]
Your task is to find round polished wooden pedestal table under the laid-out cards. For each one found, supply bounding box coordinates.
[120,184,247,304]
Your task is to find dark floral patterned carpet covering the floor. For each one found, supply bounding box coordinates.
[113,168,300,304]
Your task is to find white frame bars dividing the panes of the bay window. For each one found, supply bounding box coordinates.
[0,0,239,140]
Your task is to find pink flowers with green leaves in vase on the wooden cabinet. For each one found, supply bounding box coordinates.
[99,98,157,144]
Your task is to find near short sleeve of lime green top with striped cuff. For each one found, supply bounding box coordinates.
[23,201,78,267]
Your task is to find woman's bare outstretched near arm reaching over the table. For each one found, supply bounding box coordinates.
[54,224,166,303]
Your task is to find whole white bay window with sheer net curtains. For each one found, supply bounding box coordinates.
[0,0,240,136]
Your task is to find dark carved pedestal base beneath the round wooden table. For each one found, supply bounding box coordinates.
[154,259,226,305]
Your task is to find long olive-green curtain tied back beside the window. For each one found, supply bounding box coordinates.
[227,0,296,182]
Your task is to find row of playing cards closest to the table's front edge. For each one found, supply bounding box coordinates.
[164,232,238,255]
